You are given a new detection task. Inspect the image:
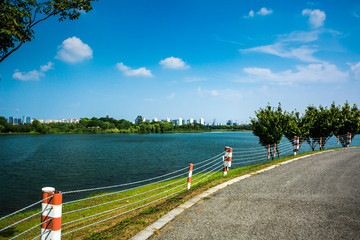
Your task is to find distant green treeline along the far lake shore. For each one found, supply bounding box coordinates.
[0,117,251,134]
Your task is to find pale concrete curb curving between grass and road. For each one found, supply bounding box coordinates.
[131,150,344,240]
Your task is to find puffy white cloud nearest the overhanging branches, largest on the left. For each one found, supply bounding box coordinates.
[55,37,93,63]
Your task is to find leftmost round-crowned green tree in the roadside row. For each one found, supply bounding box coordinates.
[250,103,286,159]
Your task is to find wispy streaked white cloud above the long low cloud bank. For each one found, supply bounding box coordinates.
[240,43,321,62]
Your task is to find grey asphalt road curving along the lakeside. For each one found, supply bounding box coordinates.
[152,148,360,240]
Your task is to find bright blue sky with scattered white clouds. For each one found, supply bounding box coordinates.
[0,0,360,122]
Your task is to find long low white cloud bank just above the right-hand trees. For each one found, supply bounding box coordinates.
[240,63,349,84]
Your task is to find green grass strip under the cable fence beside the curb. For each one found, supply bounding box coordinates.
[0,148,354,240]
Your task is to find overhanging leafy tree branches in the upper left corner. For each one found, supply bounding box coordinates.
[0,0,95,62]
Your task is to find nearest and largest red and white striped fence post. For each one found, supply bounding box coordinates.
[40,187,62,240]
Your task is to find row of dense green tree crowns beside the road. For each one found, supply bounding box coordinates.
[251,102,360,150]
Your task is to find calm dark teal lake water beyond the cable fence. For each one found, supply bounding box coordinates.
[0,132,358,215]
